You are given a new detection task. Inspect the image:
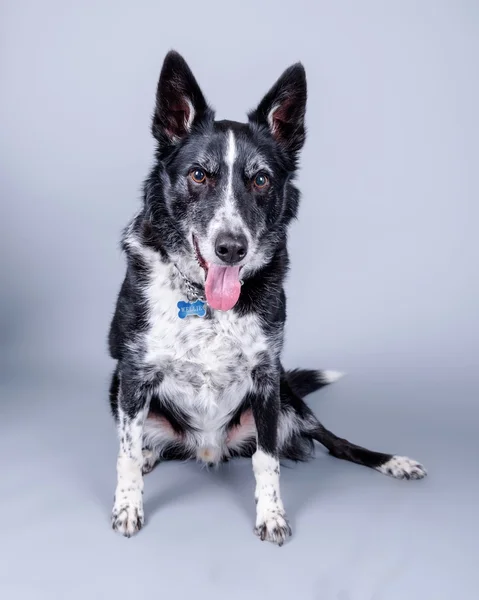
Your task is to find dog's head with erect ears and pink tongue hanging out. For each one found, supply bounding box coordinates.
[146,52,306,310]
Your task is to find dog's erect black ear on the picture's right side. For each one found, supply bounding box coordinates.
[248,63,307,155]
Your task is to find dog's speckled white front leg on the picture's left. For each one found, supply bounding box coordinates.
[111,371,149,537]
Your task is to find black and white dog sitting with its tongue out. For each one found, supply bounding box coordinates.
[109,52,426,545]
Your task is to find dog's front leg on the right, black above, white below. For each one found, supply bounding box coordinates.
[251,366,291,546]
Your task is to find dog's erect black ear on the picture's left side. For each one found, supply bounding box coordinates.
[151,50,213,145]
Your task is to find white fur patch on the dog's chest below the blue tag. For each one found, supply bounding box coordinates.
[145,266,268,446]
